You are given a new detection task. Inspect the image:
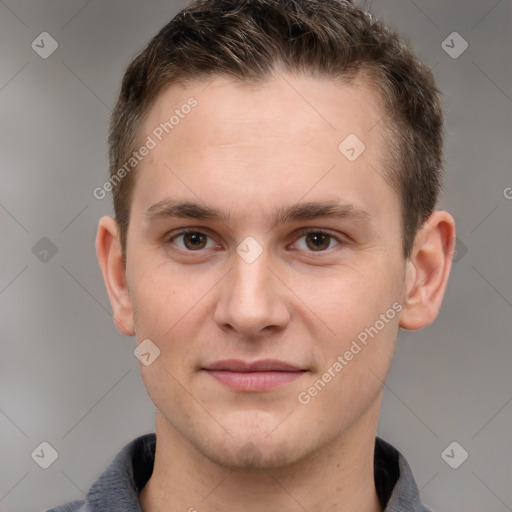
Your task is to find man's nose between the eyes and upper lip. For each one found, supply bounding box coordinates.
[215,246,290,338]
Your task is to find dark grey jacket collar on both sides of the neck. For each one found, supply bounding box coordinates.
[46,434,430,512]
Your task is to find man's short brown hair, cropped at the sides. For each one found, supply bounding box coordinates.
[109,0,443,263]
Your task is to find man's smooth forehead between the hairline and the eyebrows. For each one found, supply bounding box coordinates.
[134,74,397,228]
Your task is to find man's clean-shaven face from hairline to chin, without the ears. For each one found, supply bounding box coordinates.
[122,75,404,468]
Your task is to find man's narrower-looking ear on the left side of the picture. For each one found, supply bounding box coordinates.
[96,216,135,336]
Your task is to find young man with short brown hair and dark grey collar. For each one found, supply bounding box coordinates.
[49,0,455,512]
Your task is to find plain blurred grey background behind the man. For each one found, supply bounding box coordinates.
[0,0,512,512]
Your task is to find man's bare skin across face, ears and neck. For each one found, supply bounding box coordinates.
[96,74,455,512]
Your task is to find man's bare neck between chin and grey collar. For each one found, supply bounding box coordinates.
[139,411,382,512]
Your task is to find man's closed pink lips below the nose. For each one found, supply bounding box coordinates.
[203,359,305,392]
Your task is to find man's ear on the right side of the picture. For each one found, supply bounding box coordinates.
[400,211,455,330]
